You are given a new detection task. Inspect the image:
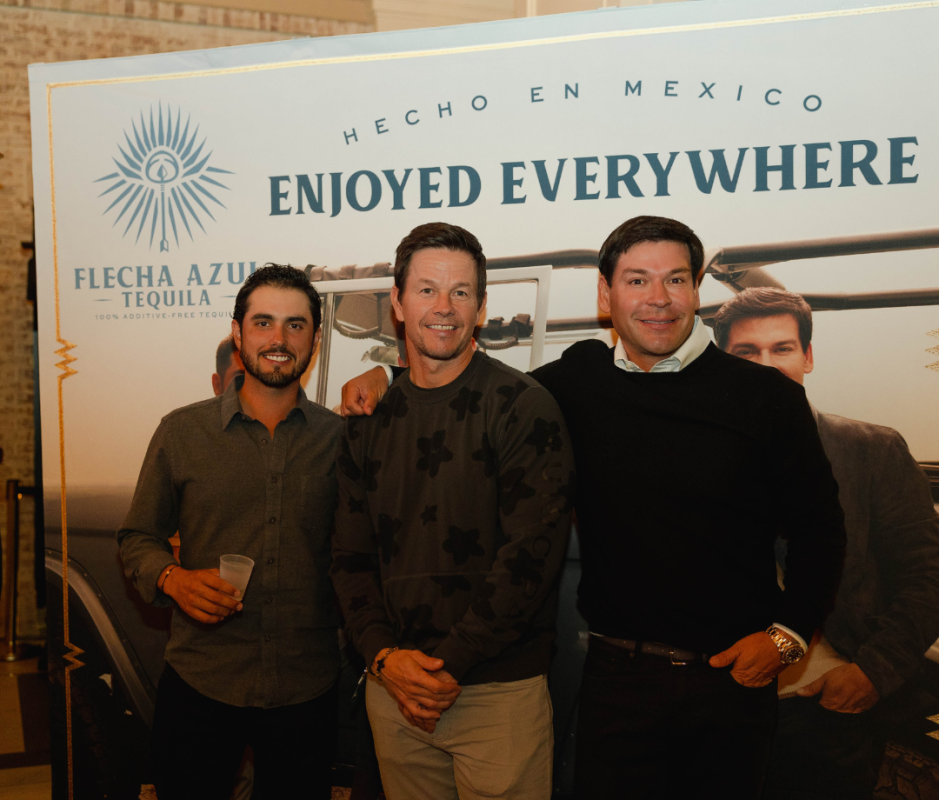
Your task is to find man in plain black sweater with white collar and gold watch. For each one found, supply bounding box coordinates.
[346,217,845,798]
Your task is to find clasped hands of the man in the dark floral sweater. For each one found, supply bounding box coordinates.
[376,650,462,733]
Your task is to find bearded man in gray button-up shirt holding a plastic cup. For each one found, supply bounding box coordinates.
[118,265,341,800]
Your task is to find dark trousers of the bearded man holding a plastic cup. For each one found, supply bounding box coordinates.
[152,664,336,800]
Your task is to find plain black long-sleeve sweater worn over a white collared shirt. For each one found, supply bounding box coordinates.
[533,341,845,653]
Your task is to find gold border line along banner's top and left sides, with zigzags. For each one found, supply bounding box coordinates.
[46,0,939,800]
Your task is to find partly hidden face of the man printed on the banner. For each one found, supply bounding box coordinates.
[726,314,815,384]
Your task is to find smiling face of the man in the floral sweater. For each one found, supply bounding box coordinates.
[391,247,481,374]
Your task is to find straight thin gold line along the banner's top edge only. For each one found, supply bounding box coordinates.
[47,0,939,90]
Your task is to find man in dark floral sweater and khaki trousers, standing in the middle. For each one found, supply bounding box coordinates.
[332,223,574,800]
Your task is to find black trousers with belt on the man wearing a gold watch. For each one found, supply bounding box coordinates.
[575,637,777,800]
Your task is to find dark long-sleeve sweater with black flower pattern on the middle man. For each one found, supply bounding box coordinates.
[332,352,574,684]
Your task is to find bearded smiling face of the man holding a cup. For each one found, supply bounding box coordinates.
[232,286,320,388]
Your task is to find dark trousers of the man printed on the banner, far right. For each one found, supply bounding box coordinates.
[763,697,885,800]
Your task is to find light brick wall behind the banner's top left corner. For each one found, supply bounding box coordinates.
[0,0,373,638]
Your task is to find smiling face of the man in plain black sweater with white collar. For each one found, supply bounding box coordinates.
[597,242,700,372]
